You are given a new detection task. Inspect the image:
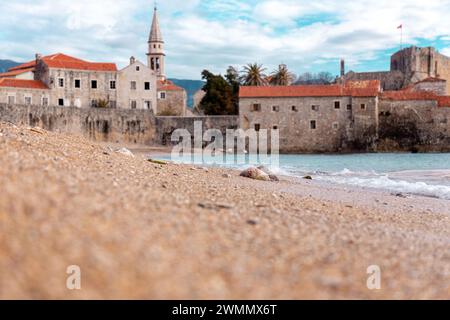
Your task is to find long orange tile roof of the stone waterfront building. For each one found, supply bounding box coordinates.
[239,80,380,98]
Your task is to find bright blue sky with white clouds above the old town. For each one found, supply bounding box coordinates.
[0,0,450,79]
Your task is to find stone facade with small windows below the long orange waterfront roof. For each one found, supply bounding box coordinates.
[239,97,378,153]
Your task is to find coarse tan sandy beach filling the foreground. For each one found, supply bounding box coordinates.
[0,123,450,299]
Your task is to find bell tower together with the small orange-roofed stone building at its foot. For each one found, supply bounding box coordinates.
[147,8,187,116]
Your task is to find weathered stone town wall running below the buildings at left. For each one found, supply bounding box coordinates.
[0,103,239,145]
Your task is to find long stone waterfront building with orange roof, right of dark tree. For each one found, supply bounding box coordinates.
[239,81,380,153]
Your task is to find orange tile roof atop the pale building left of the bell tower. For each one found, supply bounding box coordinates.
[8,53,117,71]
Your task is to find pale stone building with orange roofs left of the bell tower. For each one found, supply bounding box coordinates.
[0,53,157,112]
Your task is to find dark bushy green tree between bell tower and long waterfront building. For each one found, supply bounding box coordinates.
[199,70,237,116]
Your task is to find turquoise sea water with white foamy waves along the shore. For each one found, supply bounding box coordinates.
[154,153,450,200]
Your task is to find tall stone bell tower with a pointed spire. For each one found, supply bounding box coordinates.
[147,7,166,81]
